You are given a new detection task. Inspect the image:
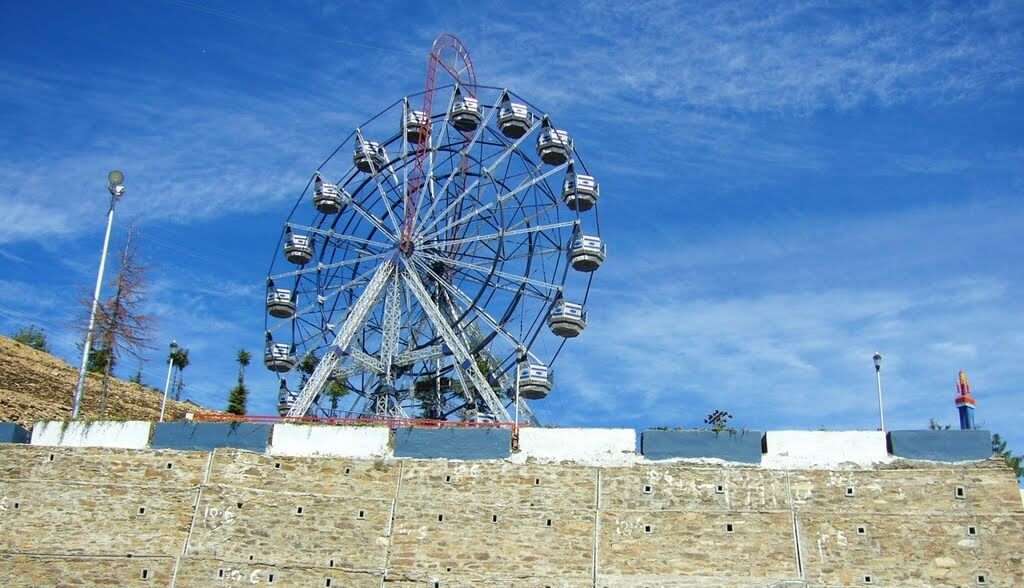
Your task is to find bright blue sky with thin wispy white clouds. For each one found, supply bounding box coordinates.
[0,0,1024,451]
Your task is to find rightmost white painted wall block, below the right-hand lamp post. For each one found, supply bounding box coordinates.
[761,431,893,469]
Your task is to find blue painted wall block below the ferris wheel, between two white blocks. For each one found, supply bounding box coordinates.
[394,427,512,459]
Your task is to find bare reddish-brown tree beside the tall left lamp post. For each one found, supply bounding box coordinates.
[83,225,154,416]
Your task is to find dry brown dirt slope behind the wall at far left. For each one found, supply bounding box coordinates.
[0,336,207,426]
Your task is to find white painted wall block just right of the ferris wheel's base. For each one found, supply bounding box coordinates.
[512,427,638,465]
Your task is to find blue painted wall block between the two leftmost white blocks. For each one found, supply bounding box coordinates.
[150,422,273,453]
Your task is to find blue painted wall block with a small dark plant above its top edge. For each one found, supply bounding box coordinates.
[640,430,764,463]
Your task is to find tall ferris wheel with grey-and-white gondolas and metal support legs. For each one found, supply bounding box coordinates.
[264,35,606,421]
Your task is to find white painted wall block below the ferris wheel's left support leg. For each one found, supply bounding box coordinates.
[268,423,391,458]
